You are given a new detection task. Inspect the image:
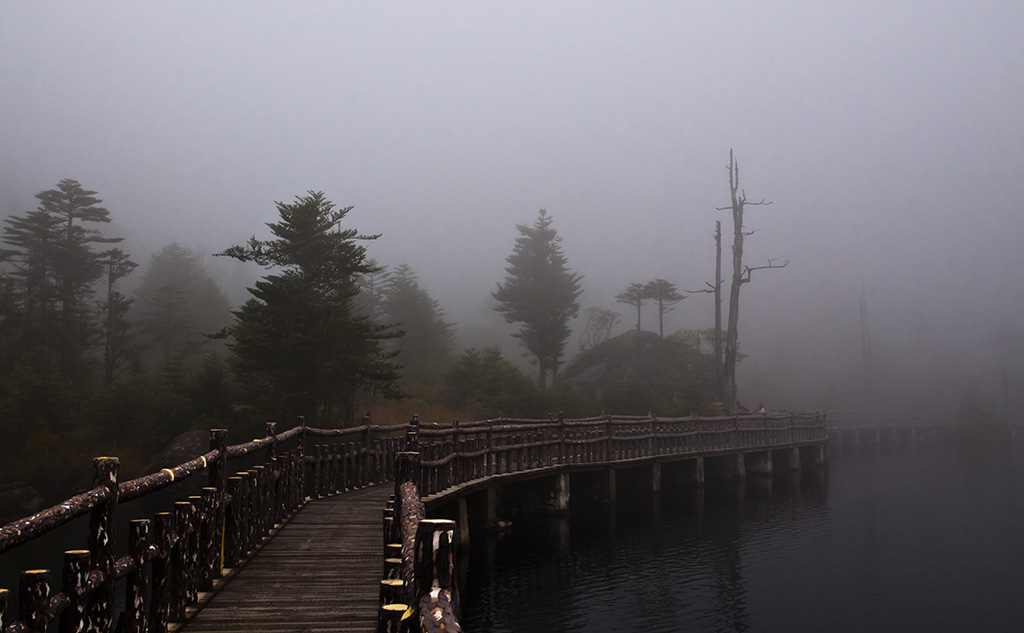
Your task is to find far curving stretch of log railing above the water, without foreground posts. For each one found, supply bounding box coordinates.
[414,413,825,497]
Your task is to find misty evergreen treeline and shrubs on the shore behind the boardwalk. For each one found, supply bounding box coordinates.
[0,171,774,496]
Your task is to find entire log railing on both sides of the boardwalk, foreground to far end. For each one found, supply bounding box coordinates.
[0,414,826,633]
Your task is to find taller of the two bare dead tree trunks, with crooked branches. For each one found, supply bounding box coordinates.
[716,150,790,414]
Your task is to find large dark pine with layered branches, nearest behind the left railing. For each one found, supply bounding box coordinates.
[217,192,398,424]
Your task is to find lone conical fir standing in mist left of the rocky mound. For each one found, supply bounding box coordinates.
[492,209,583,387]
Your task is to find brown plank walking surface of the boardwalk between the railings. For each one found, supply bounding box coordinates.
[181,484,394,633]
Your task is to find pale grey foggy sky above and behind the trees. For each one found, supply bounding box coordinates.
[0,0,1024,409]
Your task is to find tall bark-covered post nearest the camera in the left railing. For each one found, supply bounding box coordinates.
[88,457,120,631]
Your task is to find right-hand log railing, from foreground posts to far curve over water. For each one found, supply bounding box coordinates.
[378,414,826,633]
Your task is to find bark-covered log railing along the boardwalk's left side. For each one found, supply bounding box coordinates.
[0,418,408,633]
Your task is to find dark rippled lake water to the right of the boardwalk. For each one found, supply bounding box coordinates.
[462,438,1024,633]
